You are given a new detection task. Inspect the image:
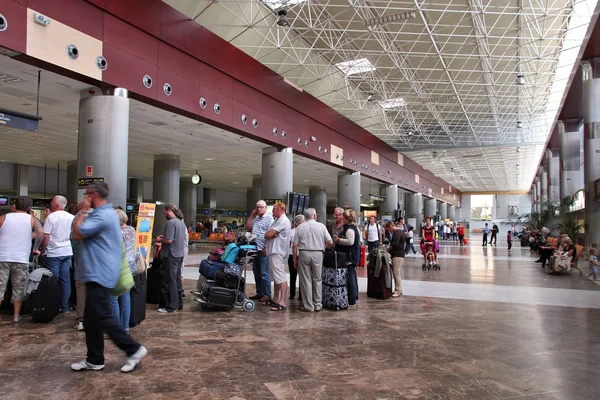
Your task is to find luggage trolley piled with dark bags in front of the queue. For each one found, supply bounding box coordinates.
[191,245,257,311]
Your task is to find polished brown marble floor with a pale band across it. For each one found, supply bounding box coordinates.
[0,238,600,400]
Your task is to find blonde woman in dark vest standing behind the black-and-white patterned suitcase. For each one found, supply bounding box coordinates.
[334,210,360,307]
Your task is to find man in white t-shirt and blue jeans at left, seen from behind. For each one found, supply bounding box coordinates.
[41,196,75,313]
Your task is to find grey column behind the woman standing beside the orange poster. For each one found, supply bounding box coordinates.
[152,154,181,235]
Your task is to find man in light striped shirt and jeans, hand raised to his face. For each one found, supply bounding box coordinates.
[246,200,273,302]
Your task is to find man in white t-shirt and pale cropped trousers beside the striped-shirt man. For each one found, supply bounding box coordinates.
[265,203,292,311]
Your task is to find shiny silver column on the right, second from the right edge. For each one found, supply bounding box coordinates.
[558,120,583,199]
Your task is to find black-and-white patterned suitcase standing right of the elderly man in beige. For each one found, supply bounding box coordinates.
[322,251,348,311]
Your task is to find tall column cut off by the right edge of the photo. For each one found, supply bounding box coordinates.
[581,58,600,248]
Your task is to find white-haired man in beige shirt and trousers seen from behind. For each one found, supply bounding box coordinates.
[292,208,333,312]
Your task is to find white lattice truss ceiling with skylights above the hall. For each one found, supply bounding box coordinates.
[163,0,597,191]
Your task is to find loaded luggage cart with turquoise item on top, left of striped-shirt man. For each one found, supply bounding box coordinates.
[191,246,258,311]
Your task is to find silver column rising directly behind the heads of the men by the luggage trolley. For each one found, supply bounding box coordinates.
[261,147,294,206]
